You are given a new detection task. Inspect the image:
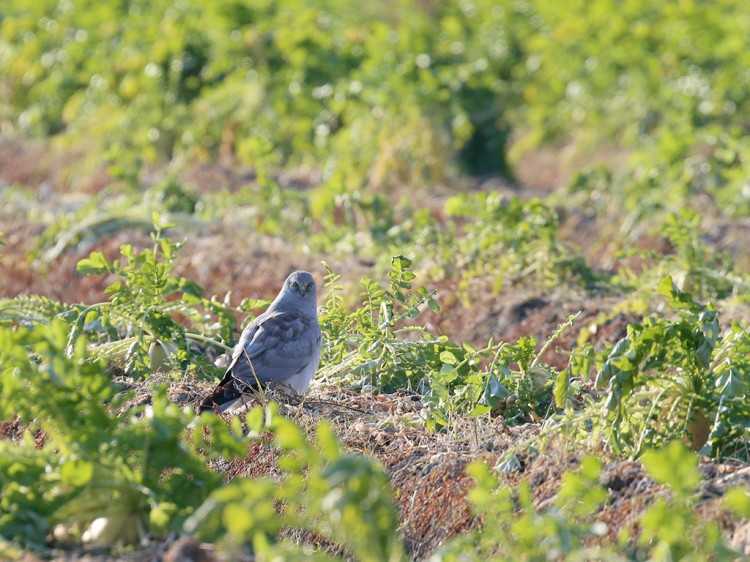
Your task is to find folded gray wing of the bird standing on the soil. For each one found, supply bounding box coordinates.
[227,311,321,384]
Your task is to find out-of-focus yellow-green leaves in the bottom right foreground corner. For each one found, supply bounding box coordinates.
[432,442,747,562]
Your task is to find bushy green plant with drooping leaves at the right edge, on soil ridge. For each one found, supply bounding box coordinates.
[579,277,750,456]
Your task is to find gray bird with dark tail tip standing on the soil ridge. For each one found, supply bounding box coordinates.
[200,271,322,412]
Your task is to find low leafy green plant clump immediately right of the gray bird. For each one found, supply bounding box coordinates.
[321,256,588,430]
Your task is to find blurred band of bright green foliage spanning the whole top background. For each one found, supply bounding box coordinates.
[0,0,750,216]
